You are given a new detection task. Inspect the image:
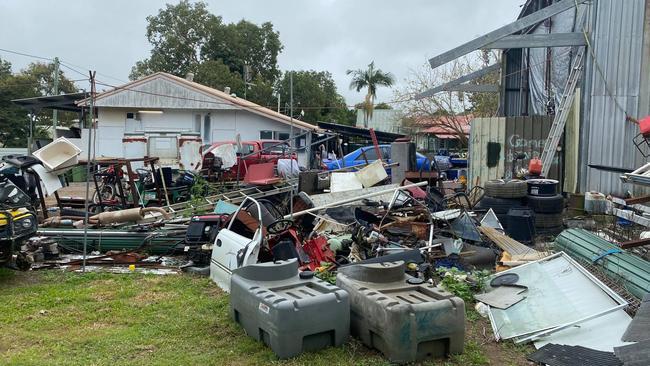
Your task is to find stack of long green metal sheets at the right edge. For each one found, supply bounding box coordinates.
[555,229,650,299]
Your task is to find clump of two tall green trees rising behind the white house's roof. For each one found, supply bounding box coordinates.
[129,0,282,91]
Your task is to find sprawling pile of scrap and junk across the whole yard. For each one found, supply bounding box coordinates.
[0,136,650,363]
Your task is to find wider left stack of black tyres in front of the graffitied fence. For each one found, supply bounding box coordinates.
[476,179,528,229]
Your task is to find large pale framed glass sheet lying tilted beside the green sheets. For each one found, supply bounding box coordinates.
[488,253,621,339]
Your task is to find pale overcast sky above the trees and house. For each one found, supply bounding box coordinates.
[0,0,525,104]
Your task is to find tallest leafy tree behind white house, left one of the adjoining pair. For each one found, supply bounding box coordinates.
[129,0,221,80]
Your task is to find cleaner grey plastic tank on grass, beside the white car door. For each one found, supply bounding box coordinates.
[230,259,350,358]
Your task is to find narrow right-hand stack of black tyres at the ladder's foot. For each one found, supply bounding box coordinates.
[526,179,564,234]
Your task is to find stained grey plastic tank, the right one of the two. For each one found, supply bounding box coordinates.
[336,261,465,363]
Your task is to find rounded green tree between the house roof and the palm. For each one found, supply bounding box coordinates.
[278,70,354,124]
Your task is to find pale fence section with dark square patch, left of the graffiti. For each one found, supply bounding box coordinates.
[468,117,506,187]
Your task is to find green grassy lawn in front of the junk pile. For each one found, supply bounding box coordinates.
[0,269,531,366]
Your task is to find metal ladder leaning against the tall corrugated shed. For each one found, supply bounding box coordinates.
[540,46,586,177]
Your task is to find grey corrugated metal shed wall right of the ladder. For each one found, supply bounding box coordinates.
[580,0,647,195]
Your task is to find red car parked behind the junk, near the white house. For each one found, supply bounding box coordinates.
[202,140,297,180]
